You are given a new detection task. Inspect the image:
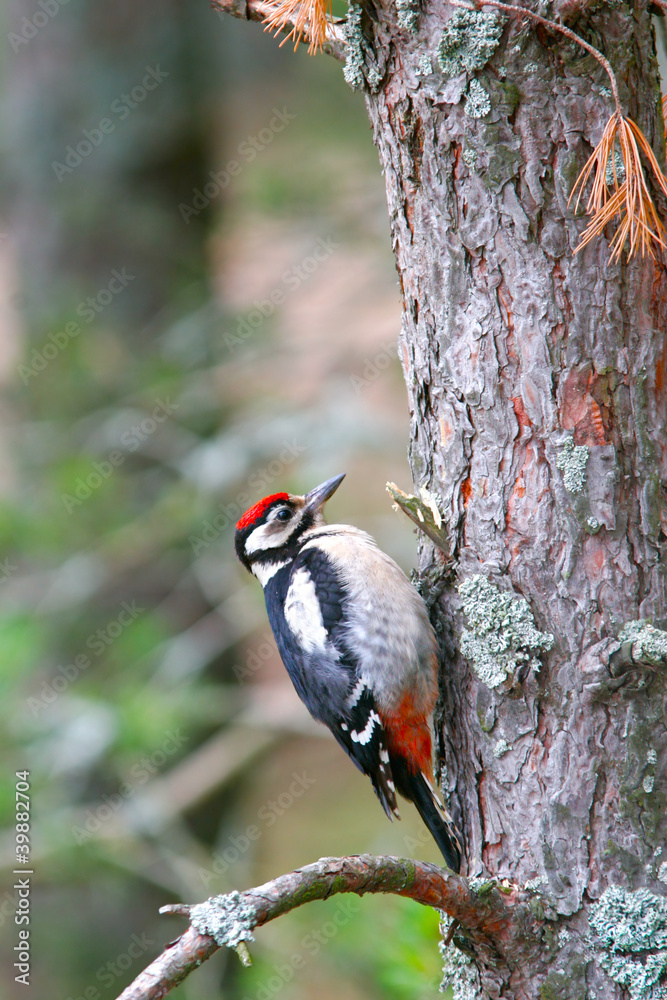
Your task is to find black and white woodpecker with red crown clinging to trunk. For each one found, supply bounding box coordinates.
[235,475,461,872]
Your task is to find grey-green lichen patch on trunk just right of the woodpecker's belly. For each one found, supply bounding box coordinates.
[458,574,554,688]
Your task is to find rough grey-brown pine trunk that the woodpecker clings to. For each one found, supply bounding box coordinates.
[125,0,667,1000]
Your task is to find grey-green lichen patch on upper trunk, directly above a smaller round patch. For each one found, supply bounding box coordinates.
[437,10,506,76]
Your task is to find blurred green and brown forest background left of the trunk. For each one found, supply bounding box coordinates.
[0,0,448,1000]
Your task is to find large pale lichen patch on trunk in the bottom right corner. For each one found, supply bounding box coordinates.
[588,885,667,1000]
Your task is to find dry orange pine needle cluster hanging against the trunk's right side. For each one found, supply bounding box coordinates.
[568,114,667,262]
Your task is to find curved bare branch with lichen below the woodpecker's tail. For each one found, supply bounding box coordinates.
[112,854,540,1000]
